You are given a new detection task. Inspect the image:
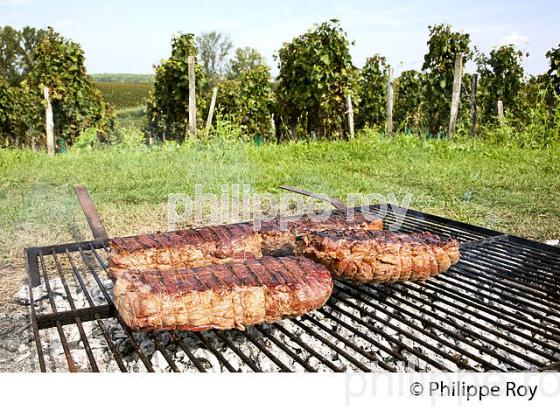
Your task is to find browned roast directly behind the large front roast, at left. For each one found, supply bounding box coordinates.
[109,223,262,279]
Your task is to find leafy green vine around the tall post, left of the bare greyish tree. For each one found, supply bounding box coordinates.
[147,34,209,141]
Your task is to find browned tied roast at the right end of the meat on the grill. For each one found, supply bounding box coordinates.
[296,230,460,283]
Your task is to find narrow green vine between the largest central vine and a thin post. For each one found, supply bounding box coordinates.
[356,54,389,128]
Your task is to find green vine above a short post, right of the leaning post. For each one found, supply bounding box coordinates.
[477,44,524,121]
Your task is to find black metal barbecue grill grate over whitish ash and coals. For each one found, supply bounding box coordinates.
[26,187,560,372]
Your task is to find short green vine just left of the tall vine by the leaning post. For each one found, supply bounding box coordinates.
[393,70,424,132]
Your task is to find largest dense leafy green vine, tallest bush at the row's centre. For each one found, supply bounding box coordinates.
[275,20,358,138]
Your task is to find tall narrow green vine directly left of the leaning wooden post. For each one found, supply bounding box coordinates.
[422,24,472,134]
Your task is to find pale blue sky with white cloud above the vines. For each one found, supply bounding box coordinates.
[0,0,560,74]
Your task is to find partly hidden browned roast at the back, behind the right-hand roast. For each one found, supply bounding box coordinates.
[260,213,383,255]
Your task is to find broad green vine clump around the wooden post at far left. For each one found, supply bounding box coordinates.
[0,28,113,145]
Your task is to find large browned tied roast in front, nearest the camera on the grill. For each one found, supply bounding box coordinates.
[114,256,333,330]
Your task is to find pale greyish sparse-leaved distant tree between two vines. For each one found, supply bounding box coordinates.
[196,31,233,87]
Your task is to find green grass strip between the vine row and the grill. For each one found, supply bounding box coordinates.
[0,135,560,310]
